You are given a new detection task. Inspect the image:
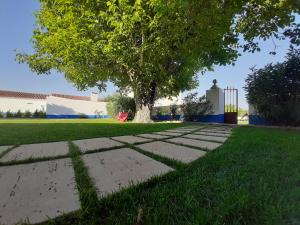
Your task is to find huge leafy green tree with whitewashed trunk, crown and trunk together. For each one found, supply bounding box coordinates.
[17,0,299,122]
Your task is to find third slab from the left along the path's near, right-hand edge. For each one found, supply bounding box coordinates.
[137,141,206,163]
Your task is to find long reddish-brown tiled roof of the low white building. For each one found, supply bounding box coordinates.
[0,90,105,102]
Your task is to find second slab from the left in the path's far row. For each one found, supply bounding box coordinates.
[73,138,124,153]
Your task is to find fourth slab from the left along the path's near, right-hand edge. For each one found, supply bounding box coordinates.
[167,137,222,150]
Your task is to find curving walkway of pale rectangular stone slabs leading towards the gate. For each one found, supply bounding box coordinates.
[0,125,232,225]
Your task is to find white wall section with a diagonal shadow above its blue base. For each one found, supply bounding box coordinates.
[46,96,107,115]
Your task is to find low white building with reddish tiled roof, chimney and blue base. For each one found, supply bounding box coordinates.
[0,90,108,118]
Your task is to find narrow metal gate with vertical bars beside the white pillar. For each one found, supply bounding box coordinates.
[224,87,238,124]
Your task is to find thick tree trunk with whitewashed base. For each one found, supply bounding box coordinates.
[134,82,157,123]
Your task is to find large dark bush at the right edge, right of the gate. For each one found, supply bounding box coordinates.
[244,49,300,126]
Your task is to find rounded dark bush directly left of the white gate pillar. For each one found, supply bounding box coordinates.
[181,93,212,121]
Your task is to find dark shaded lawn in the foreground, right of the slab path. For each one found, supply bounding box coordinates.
[37,127,300,225]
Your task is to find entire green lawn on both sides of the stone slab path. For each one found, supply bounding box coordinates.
[0,120,300,225]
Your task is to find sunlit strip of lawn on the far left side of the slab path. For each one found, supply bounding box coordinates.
[0,119,184,146]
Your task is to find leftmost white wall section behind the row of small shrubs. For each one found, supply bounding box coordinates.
[0,97,46,113]
